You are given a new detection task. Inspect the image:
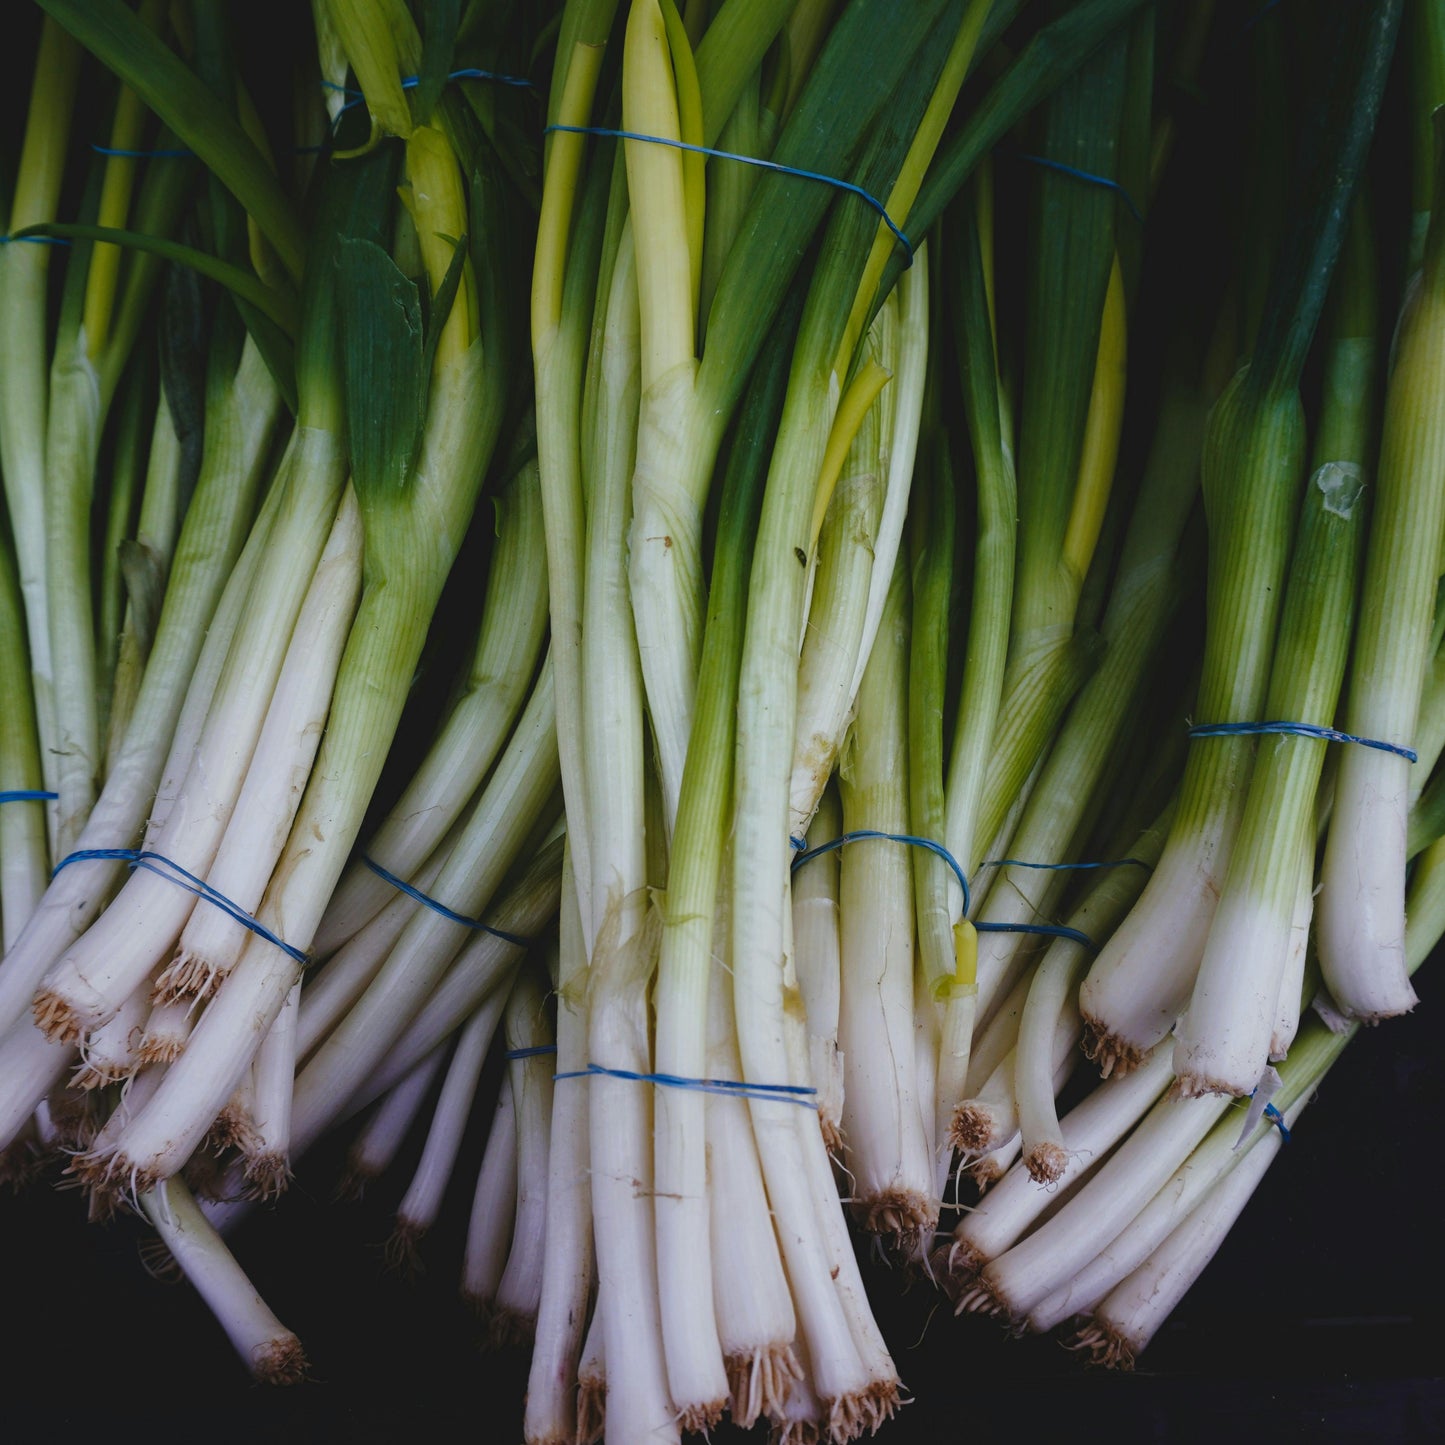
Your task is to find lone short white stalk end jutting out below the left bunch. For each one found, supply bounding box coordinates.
[140,1179,306,1384]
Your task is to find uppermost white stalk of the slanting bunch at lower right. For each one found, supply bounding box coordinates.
[946,1049,1173,1277]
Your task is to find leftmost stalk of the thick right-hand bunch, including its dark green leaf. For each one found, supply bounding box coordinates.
[1081,4,1398,1072]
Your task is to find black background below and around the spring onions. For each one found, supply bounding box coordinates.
[0,0,1445,1445]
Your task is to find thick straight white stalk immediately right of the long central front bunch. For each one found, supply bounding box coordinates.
[838,566,938,1251]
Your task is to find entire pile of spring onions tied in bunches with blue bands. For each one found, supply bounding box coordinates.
[0,0,1445,1445]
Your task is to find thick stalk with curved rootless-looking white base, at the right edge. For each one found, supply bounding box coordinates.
[1315,155,1445,1022]
